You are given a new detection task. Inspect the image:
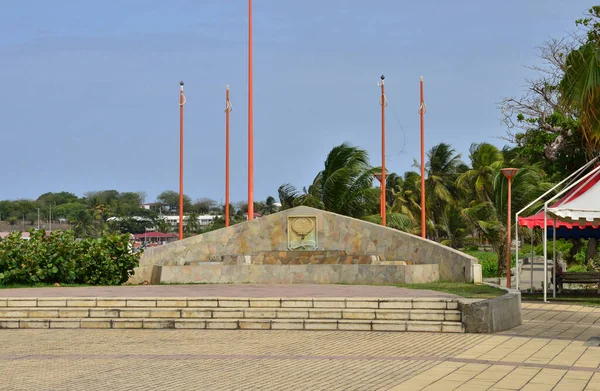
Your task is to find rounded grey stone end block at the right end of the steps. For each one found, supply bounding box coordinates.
[458,284,521,333]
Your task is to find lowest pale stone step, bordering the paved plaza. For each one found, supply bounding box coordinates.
[0,318,464,333]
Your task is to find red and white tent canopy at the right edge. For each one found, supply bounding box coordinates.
[519,170,600,230]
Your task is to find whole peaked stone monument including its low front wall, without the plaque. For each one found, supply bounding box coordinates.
[130,207,480,284]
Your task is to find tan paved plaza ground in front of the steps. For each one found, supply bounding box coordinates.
[0,303,600,391]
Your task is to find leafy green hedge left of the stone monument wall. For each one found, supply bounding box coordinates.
[0,230,141,285]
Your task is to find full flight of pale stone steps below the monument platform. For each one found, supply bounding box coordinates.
[0,297,464,333]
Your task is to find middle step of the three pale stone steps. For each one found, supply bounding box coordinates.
[0,307,461,322]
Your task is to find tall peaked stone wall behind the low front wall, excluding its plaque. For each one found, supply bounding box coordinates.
[130,207,477,283]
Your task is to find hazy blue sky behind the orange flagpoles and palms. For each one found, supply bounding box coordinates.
[0,0,592,205]
